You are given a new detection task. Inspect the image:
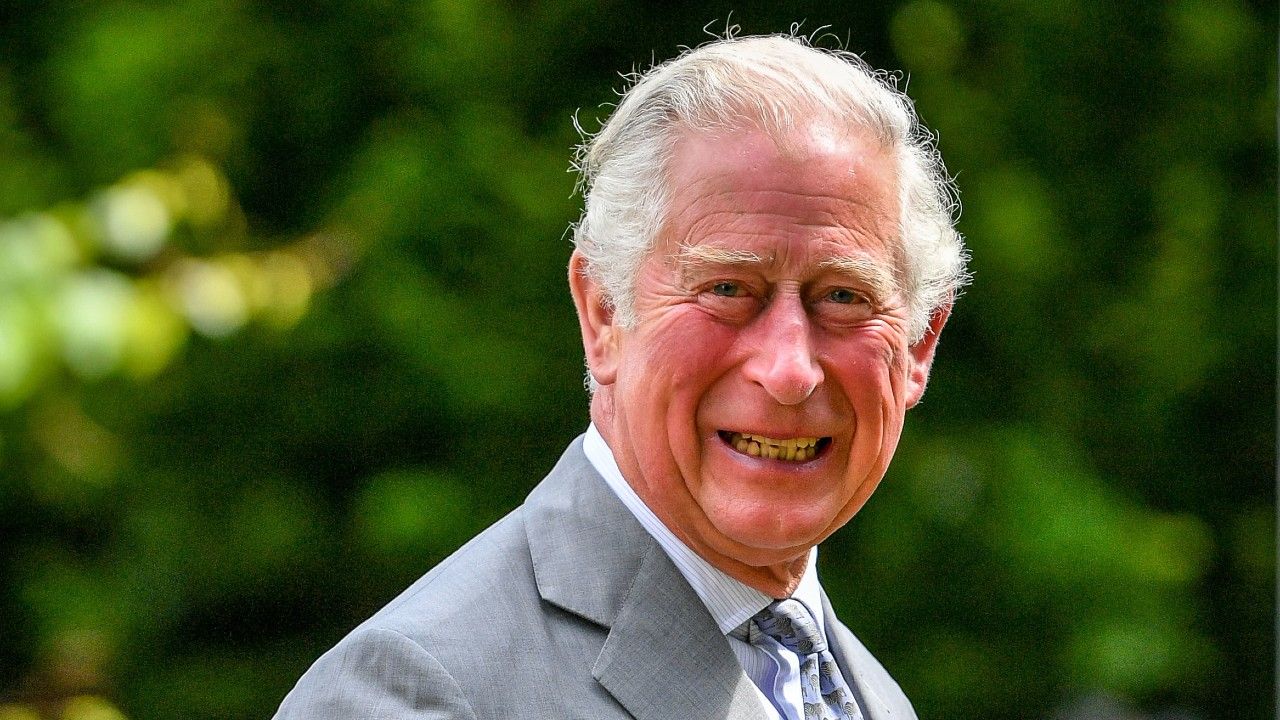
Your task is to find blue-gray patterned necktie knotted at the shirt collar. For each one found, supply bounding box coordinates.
[751,597,863,720]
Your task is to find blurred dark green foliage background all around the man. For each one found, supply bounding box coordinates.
[0,0,1276,720]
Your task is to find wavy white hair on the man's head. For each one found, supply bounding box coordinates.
[573,35,968,343]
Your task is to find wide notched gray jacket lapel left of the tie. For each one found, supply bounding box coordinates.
[525,438,767,720]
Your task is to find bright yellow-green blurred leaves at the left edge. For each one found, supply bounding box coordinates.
[0,158,334,407]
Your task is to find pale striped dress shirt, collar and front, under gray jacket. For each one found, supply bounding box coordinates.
[582,423,827,720]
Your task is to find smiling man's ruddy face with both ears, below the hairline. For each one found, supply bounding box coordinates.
[575,126,946,577]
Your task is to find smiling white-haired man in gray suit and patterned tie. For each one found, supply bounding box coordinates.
[278,37,965,720]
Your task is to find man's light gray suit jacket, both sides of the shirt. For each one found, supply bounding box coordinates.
[275,438,915,720]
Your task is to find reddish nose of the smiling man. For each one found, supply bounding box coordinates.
[744,296,823,405]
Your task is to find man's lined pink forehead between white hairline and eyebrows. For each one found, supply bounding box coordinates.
[663,126,899,269]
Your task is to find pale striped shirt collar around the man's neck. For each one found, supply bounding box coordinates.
[582,423,826,634]
